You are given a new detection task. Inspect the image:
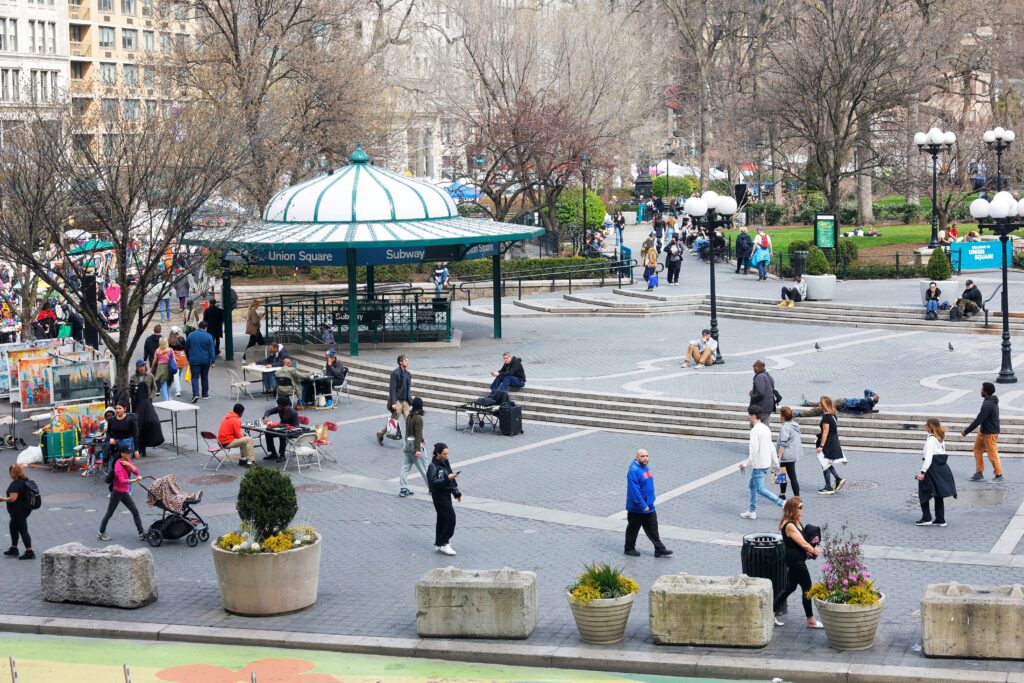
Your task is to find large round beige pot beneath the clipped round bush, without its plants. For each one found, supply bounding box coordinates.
[211,533,323,616]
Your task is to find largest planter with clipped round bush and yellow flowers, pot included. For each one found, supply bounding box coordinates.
[212,467,323,616]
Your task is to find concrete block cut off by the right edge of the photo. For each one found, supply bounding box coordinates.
[921,583,1024,659]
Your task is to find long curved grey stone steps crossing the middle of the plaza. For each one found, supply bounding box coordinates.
[293,350,1024,457]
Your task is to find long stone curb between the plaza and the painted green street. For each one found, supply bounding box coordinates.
[0,614,1024,683]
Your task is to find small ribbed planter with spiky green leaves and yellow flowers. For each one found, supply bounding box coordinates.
[565,563,640,645]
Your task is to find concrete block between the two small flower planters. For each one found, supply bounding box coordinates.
[649,573,775,647]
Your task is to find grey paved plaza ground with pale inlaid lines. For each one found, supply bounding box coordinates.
[0,276,1024,680]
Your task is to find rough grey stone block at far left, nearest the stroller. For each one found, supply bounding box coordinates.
[42,543,157,609]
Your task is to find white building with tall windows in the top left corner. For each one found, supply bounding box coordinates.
[0,0,68,140]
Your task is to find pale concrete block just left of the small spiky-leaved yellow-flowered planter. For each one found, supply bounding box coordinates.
[416,566,538,638]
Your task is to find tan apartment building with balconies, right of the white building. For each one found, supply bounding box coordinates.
[66,0,194,137]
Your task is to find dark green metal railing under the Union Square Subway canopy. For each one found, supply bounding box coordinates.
[263,289,453,344]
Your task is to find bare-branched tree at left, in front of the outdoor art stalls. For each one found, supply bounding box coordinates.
[0,101,242,388]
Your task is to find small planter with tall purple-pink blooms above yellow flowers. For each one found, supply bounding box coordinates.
[807,525,886,650]
